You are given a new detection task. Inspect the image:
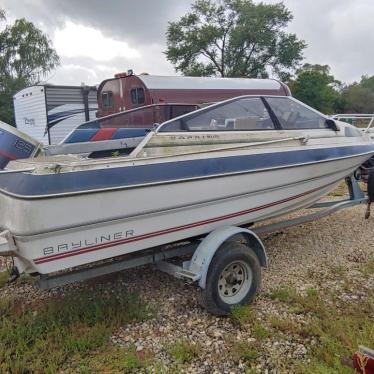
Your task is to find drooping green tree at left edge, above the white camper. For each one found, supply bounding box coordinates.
[0,9,59,124]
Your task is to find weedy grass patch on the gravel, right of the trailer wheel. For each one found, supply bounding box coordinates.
[268,287,374,374]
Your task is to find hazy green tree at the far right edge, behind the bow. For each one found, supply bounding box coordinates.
[342,75,374,113]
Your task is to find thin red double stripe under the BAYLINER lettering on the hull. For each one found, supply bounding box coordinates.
[34,188,320,265]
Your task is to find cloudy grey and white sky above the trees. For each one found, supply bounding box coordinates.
[0,0,374,85]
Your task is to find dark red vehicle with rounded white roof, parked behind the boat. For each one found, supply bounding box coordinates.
[97,71,290,120]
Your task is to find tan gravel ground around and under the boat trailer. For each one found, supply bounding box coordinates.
[0,206,374,373]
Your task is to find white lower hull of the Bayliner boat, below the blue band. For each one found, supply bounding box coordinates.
[7,150,368,274]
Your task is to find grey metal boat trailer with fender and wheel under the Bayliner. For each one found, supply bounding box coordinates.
[0,176,368,315]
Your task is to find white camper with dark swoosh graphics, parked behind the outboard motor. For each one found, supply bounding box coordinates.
[13,84,97,144]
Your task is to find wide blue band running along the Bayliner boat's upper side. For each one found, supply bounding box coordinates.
[0,144,374,196]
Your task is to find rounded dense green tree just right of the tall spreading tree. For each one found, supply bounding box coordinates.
[288,64,341,114]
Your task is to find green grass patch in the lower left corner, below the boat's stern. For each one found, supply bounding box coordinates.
[0,289,149,373]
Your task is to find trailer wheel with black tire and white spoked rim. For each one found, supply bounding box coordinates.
[201,241,261,316]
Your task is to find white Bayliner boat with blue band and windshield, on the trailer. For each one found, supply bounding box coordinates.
[0,95,374,274]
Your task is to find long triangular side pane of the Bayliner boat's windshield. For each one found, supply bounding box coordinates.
[159,97,275,132]
